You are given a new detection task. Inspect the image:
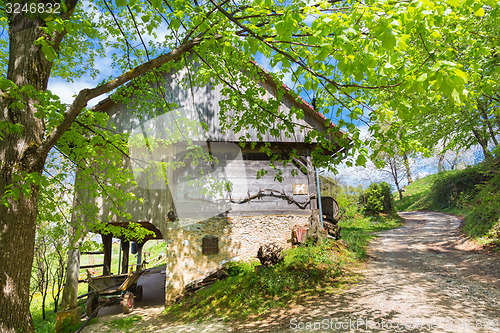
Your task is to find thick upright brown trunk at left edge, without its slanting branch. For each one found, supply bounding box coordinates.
[0,8,51,333]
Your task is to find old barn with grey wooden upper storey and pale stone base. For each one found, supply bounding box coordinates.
[84,63,343,301]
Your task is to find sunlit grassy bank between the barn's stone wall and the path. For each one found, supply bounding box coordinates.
[164,213,401,322]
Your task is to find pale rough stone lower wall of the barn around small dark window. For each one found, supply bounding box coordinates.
[164,215,309,302]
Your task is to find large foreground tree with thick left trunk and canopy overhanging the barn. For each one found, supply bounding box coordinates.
[0,0,492,332]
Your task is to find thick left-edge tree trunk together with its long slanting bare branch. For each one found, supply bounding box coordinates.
[0,4,197,333]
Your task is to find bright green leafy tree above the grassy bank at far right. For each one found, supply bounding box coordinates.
[380,1,500,165]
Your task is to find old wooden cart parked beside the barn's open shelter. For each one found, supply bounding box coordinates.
[85,270,144,317]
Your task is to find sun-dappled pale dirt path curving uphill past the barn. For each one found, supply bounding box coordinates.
[84,212,500,332]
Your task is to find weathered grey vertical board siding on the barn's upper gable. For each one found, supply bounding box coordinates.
[105,71,334,143]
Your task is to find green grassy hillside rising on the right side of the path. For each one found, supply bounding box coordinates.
[395,161,500,249]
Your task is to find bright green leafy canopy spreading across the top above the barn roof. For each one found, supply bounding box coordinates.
[0,0,499,232]
